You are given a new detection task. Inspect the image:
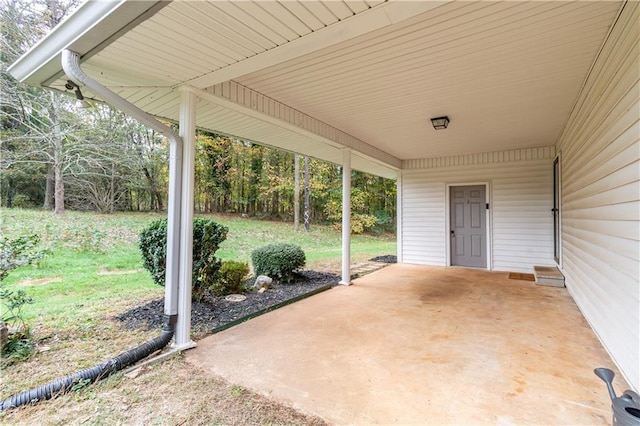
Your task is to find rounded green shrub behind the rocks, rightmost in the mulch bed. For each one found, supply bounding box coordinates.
[251,243,306,282]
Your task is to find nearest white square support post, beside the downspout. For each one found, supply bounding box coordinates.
[174,89,196,349]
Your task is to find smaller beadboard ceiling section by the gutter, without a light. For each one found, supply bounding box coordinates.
[91,1,369,85]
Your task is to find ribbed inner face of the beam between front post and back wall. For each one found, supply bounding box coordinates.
[188,82,402,170]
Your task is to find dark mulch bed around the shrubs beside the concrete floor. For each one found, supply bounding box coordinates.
[115,271,340,335]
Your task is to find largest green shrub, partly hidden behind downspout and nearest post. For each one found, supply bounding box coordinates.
[140,218,229,300]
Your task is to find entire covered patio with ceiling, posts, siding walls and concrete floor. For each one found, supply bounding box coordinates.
[8,0,640,410]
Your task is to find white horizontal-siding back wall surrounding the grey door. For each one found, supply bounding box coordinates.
[399,147,555,272]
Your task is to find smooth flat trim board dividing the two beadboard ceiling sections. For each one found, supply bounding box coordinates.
[183,0,451,89]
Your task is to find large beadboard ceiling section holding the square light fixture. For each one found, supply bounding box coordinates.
[236,2,620,160]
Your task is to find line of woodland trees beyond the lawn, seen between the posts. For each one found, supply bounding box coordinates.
[0,0,396,232]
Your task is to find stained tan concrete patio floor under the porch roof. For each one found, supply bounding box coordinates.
[185,265,629,425]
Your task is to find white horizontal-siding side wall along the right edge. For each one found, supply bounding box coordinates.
[557,2,640,390]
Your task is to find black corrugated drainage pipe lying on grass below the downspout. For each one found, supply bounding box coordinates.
[0,315,177,411]
